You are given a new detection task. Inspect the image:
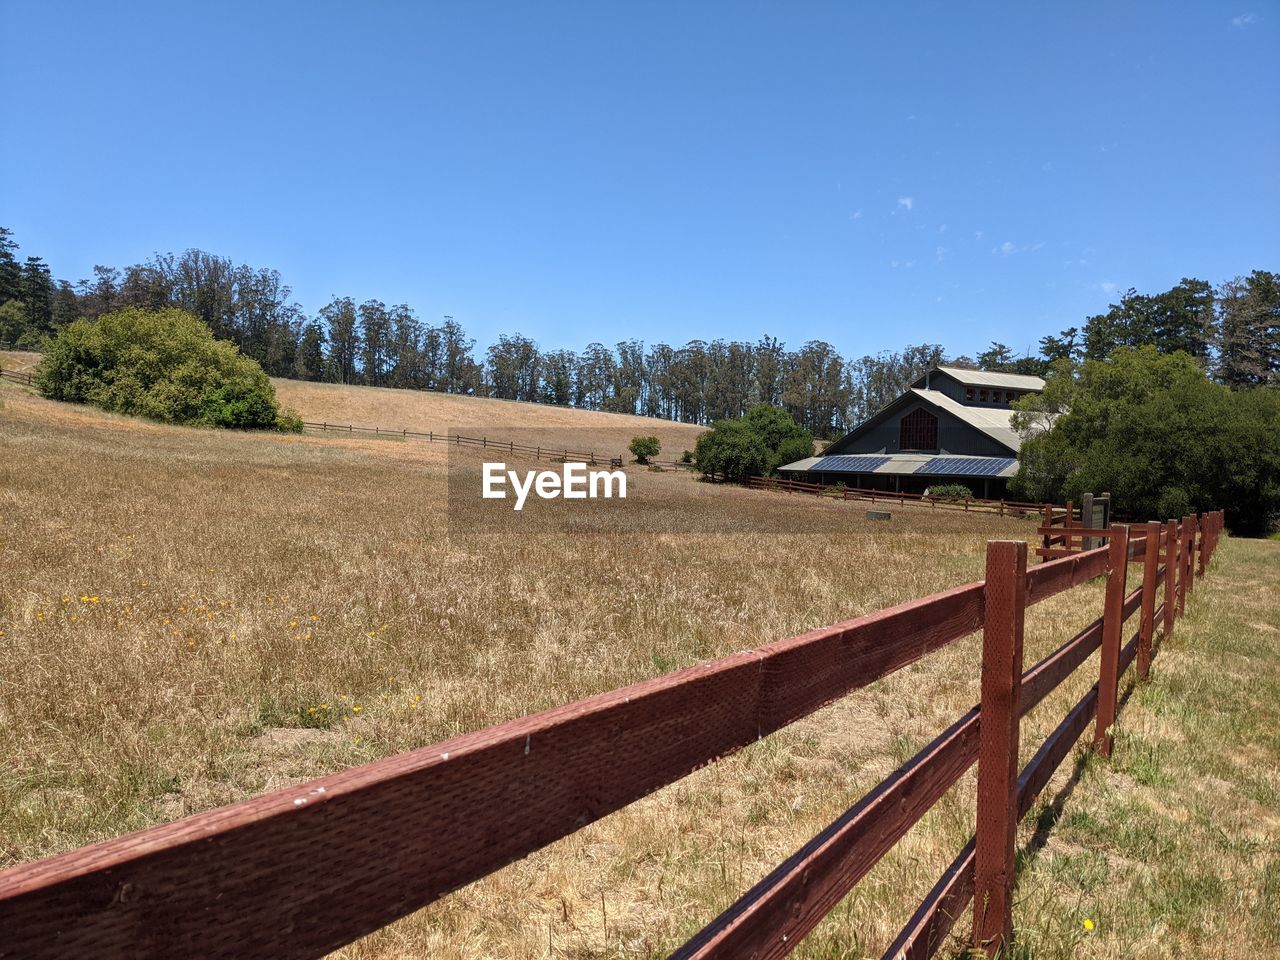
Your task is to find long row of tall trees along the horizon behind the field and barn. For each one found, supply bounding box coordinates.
[0,228,1280,438]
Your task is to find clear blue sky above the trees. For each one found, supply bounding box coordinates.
[0,0,1280,356]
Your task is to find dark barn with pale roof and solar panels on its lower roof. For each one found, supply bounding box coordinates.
[778,366,1044,498]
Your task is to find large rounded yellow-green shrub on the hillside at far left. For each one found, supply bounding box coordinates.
[36,308,302,431]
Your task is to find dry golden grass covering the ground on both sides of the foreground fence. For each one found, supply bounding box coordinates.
[0,378,1280,960]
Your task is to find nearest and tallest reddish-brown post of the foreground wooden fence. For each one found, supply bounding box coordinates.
[973,540,1027,956]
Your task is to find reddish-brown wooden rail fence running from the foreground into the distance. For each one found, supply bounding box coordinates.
[0,513,1222,959]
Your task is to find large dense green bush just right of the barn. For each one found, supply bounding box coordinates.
[1010,347,1280,535]
